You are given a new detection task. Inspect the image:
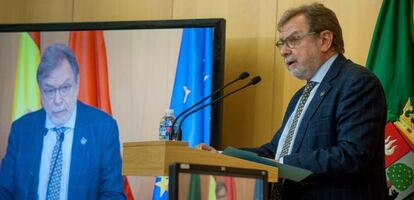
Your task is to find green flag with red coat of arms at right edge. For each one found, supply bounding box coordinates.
[367,0,414,199]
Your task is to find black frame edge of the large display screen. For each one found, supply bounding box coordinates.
[0,18,226,148]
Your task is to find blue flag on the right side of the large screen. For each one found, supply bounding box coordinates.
[170,28,213,147]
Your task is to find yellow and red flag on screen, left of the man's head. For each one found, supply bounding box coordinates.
[12,32,41,120]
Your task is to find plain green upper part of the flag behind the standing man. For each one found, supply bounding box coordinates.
[366,0,414,122]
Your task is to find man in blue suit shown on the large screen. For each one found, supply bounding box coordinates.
[0,44,125,199]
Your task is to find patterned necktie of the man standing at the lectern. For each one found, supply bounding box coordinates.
[279,81,316,158]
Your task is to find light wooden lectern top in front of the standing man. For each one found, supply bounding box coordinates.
[122,141,278,182]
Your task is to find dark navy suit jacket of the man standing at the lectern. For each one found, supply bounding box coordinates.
[248,55,387,200]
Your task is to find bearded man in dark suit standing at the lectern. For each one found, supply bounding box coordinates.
[201,3,387,200]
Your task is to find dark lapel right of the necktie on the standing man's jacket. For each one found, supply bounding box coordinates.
[292,54,346,152]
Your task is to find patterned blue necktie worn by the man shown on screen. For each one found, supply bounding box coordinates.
[46,127,67,200]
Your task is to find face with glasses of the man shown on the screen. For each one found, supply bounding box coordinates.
[40,60,79,125]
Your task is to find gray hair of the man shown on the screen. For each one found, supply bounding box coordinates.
[36,44,79,85]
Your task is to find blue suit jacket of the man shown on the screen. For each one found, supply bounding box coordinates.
[0,102,125,199]
